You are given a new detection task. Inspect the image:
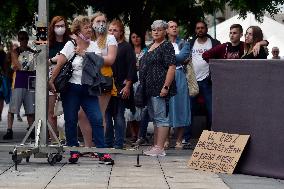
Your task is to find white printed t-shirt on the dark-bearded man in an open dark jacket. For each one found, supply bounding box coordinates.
[192,38,212,81]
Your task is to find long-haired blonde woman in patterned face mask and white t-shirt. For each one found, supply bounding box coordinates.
[76,12,117,147]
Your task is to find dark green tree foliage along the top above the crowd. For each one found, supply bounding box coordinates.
[0,0,284,41]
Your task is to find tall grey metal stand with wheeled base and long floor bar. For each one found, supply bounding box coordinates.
[11,0,142,170]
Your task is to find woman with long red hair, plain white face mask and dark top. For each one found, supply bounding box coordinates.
[48,16,70,141]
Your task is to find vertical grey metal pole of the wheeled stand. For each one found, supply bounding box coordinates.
[34,0,48,146]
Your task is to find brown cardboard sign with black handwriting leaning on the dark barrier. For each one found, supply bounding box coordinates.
[188,130,249,174]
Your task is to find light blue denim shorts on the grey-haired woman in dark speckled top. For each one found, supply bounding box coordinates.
[147,97,169,127]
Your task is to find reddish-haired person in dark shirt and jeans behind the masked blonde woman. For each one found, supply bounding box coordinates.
[105,20,137,149]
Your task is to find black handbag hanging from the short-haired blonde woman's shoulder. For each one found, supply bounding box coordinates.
[54,40,76,93]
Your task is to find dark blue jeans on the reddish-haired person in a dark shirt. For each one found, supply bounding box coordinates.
[105,96,126,149]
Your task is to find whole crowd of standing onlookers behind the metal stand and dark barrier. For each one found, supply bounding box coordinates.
[0,12,280,162]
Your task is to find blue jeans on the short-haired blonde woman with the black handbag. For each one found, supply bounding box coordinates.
[61,83,105,148]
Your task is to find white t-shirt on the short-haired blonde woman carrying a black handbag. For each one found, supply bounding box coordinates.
[60,41,96,85]
